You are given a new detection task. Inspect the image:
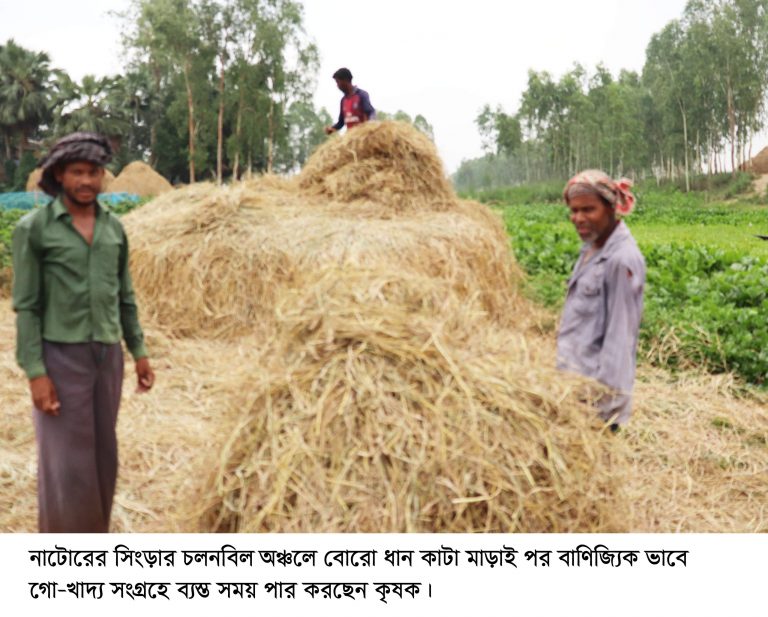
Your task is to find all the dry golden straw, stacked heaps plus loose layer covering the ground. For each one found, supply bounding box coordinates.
[0,123,768,531]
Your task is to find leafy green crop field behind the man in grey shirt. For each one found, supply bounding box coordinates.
[479,183,768,385]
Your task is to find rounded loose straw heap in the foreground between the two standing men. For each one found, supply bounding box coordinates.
[204,268,627,532]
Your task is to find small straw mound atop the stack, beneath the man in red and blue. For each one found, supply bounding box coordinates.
[299,122,456,213]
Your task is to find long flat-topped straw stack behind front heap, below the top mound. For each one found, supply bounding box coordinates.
[125,179,519,338]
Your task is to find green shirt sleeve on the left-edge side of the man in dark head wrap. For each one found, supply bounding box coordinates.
[11,222,46,379]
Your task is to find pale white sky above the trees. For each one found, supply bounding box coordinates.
[0,0,685,172]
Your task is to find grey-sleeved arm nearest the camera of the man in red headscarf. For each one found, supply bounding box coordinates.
[597,254,645,393]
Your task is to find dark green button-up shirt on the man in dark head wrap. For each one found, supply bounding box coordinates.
[12,198,147,379]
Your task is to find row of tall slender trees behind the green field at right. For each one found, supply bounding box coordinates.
[454,0,768,189]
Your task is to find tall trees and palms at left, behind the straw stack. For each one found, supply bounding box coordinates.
[0,0,432,190]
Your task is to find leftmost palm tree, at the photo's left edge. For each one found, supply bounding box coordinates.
[0,39,53,158]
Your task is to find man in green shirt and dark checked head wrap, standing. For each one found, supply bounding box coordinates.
[13,133,155,533]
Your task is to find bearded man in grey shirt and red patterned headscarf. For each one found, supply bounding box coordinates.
[557,170,645,431]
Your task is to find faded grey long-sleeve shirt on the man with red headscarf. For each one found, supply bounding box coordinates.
[557,221,645,424]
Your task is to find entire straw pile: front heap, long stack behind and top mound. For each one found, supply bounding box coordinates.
[124,123,626,531]
